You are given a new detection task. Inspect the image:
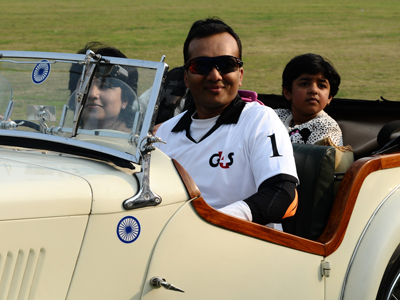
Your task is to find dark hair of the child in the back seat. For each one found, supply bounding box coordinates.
[282,53,340,97]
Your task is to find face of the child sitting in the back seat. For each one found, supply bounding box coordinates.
[283,73,332,124]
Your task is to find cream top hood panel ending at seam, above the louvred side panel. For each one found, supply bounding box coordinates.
[0,149,92,220]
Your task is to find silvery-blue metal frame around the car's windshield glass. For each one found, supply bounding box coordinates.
[0,50,168,165]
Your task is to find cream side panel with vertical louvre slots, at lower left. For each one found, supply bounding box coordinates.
[0,215,88,299]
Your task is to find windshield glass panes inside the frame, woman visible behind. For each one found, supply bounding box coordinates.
[0,56,157,158]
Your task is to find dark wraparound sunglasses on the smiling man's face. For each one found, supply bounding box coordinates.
[185,55,243,75]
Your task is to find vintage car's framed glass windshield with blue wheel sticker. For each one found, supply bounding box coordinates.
[0,51,167,162]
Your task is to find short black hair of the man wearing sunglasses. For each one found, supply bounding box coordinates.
[183,17,242,62]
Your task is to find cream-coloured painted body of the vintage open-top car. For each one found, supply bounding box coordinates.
[0,52,400,300]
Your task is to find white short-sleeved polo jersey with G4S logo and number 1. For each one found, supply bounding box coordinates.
[157,98,298,209]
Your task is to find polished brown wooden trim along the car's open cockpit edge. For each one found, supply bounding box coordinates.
[173,154,400,256]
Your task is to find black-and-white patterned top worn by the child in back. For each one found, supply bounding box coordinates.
[275,108,343,146]
